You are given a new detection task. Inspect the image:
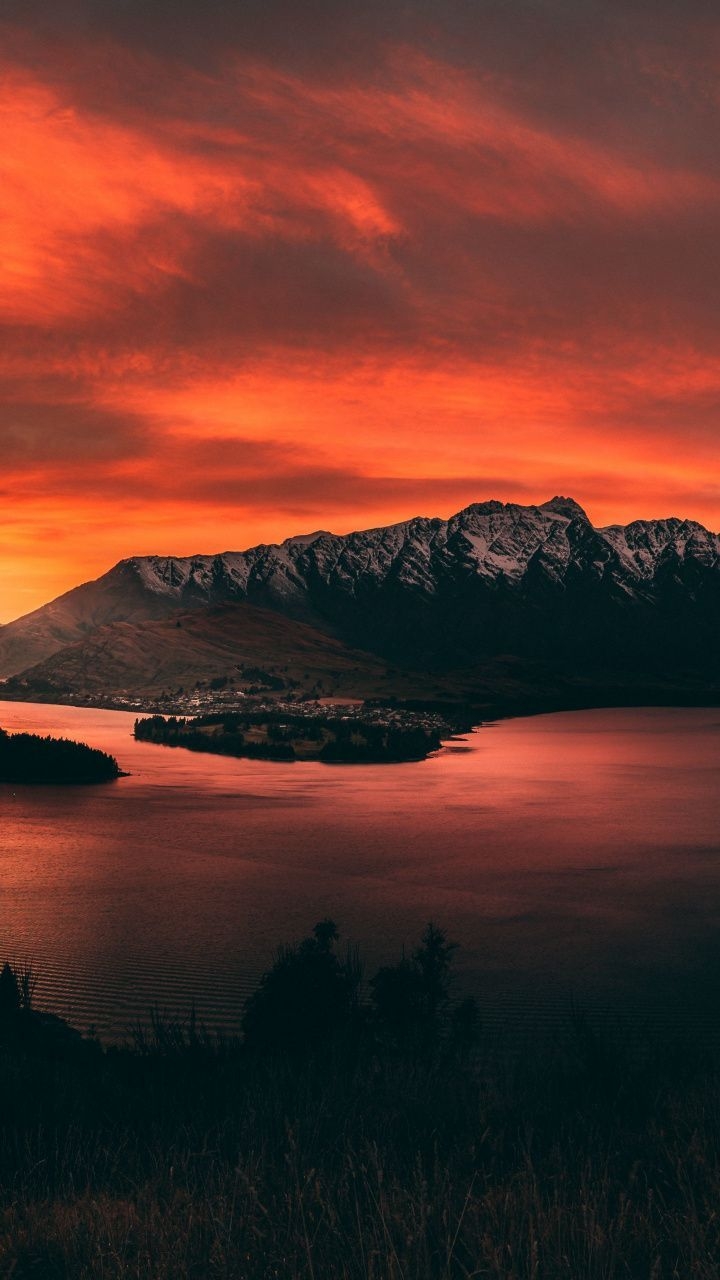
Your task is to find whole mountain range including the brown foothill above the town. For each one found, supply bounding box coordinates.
[0,498,720,696]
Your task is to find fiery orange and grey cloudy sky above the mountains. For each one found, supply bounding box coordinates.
[0,0,720,621]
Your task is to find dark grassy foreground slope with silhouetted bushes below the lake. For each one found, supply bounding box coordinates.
[0,922,720,1280]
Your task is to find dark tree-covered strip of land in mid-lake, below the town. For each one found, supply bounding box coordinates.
[135,709,450,764]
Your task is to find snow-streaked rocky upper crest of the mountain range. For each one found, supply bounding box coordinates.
[90,495,720,624]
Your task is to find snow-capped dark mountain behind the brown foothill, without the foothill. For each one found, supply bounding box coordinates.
[0,498,720,675]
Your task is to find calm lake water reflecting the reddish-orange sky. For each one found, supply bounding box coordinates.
[0,703,720,1036]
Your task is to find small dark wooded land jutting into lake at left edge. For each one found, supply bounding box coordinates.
[0,728,123,786]
